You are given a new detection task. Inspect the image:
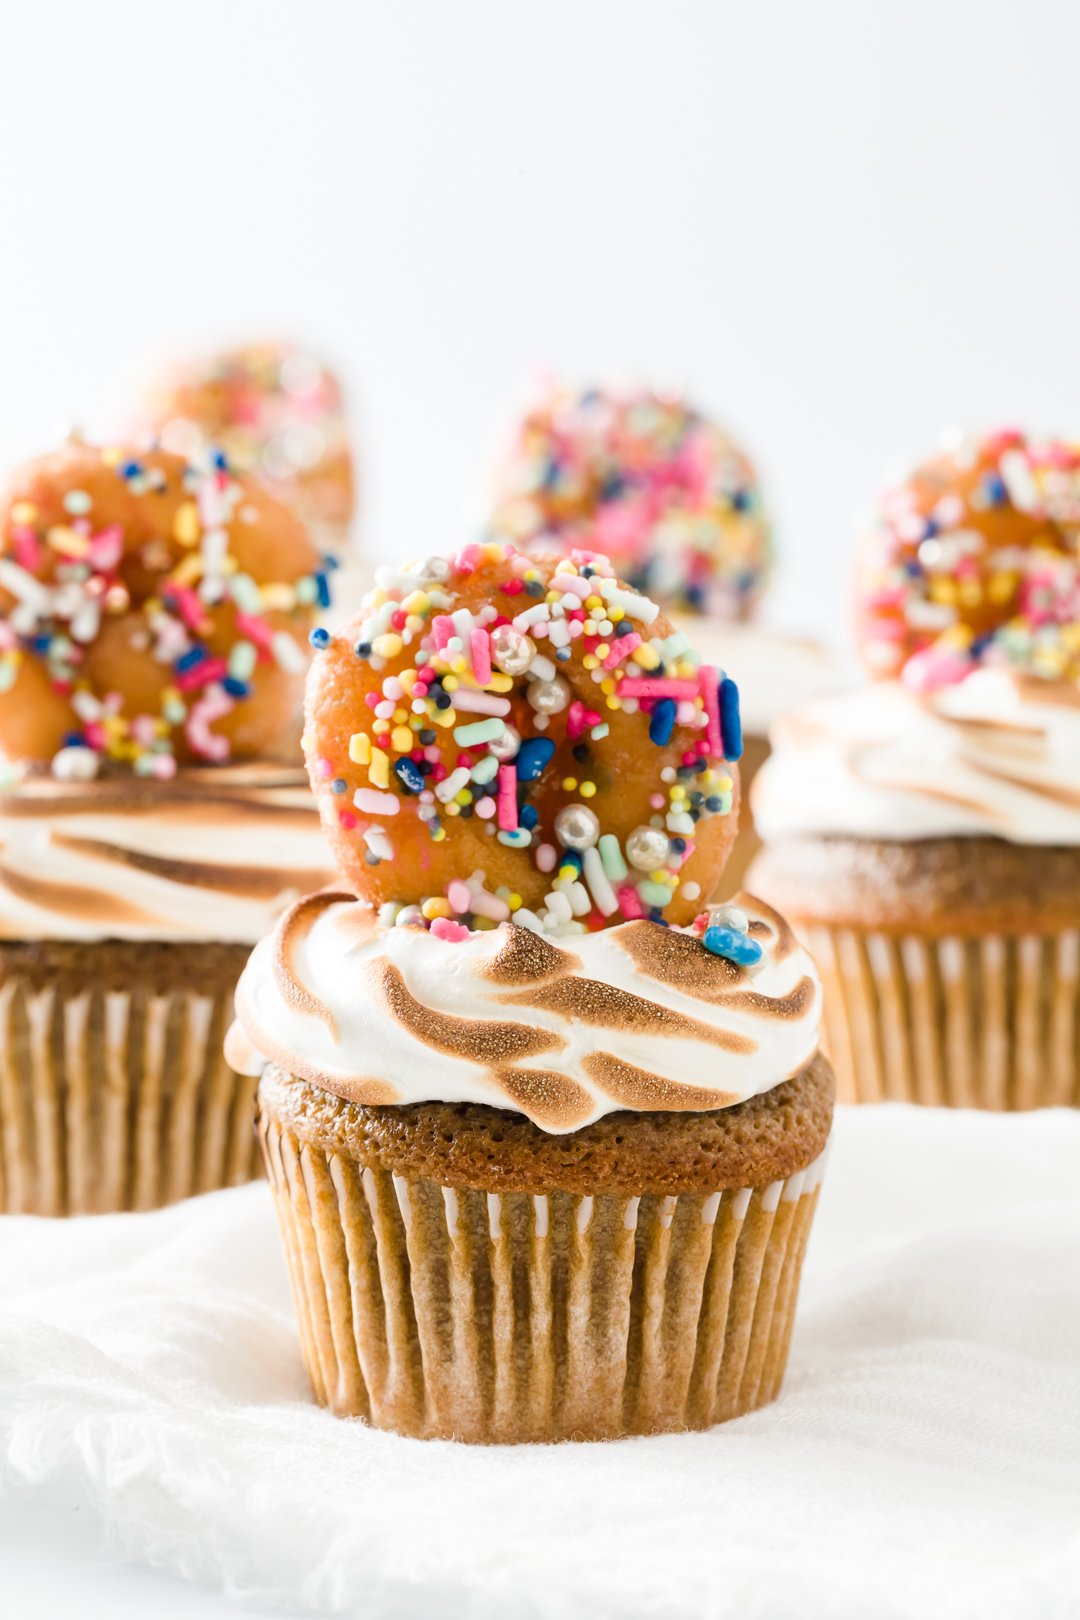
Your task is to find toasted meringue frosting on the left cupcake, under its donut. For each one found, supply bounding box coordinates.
[0,765,332,944]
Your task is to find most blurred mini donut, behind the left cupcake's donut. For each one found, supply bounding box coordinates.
[149,343,355,544]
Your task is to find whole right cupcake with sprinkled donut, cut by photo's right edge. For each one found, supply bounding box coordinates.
[750,431,1080,1108]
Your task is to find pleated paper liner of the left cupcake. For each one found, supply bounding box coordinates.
[0,974,261,1215]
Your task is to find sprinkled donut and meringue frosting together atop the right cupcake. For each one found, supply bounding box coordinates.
[753,431,1080,846]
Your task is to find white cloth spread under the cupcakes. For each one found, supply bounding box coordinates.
[0,1106,1080,1620]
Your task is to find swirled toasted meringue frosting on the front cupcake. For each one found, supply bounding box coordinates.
[227,891,821,1134]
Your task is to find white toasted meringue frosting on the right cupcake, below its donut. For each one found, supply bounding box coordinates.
[751,669,1080,846]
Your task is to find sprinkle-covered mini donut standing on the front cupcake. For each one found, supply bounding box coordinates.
[304,543,742,933]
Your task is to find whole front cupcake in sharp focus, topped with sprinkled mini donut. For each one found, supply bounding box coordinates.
[227,544,832,1442]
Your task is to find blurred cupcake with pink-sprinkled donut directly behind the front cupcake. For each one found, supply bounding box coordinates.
[491,387,836,889]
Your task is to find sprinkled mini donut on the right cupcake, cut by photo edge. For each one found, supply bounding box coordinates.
[857,429,1080,692]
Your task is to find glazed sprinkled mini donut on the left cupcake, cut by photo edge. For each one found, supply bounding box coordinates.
[0,442,330,778]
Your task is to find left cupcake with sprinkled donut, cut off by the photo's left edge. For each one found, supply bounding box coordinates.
[0,444,329,1215]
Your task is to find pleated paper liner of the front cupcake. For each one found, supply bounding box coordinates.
[259,1108,824,1442]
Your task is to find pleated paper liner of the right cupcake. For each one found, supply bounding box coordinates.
[809,925,1080,1110]
